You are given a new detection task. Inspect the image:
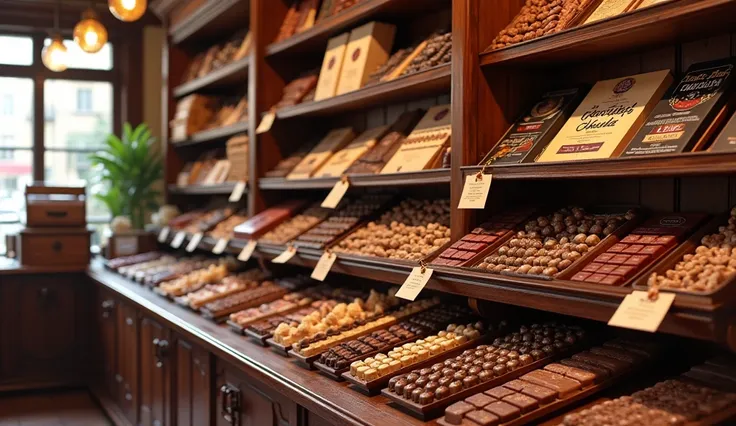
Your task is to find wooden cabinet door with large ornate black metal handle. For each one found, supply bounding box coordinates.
[215,359,299,426]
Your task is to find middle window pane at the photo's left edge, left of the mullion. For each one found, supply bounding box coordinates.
[0,77,33,148]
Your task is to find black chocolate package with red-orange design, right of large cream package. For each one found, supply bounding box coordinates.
[622,58,736,157]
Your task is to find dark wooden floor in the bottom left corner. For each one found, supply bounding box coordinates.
[0,390,112,426]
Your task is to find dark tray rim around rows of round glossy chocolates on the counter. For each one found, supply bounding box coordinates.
[381,345,586,421]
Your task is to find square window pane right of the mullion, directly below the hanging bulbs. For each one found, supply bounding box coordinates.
[44,80,113,150]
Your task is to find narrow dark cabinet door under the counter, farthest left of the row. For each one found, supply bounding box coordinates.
[96,288,118,400]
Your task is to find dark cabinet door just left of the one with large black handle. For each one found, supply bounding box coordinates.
[174,338,212,426]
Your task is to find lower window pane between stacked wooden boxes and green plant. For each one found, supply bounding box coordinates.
[44,151,110,221]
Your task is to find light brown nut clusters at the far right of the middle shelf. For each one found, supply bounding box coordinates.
[647,208,736,293]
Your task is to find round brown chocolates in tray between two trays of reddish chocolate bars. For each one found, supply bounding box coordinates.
[478,207,635,277]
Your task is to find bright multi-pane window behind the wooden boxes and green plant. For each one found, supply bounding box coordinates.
[0,34,115,254]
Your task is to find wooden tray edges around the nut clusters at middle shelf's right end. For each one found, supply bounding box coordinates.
[633,213,736,305]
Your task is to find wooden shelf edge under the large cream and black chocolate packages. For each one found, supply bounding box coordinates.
[462,152,736,180]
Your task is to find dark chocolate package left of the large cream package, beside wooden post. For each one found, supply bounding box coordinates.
[480,88,582,165]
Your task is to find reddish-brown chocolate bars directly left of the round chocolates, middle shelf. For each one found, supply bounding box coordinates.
[432,209,532,266]
